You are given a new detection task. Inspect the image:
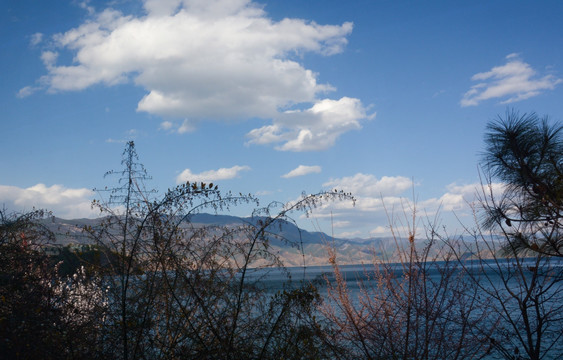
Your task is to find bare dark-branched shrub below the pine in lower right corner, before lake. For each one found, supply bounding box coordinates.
[447,219,563,359]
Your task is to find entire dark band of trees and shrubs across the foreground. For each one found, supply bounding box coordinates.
[0,112,563,360]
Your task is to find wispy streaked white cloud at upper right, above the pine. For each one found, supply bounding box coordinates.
[460,54,563,106]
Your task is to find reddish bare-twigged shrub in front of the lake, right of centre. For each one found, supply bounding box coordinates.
[323,201,490,359]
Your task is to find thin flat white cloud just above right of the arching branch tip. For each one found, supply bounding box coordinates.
[323,173,413,198]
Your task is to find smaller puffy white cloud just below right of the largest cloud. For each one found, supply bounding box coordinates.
[247,97,375,151]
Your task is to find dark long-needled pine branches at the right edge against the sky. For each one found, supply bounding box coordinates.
[482,110,563,257]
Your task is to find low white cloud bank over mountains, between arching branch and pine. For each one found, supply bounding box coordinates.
[304,173,505,237]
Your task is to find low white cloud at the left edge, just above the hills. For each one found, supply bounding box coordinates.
[0,184,98,218]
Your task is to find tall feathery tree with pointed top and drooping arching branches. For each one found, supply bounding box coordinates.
[86,142,351,359]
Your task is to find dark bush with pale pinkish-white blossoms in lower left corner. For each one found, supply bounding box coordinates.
[0,209,109,359]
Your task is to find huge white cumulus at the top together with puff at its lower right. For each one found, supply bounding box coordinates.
[24,0,368,151]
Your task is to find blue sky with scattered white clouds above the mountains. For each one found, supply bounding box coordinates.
[0,0,563,238]
